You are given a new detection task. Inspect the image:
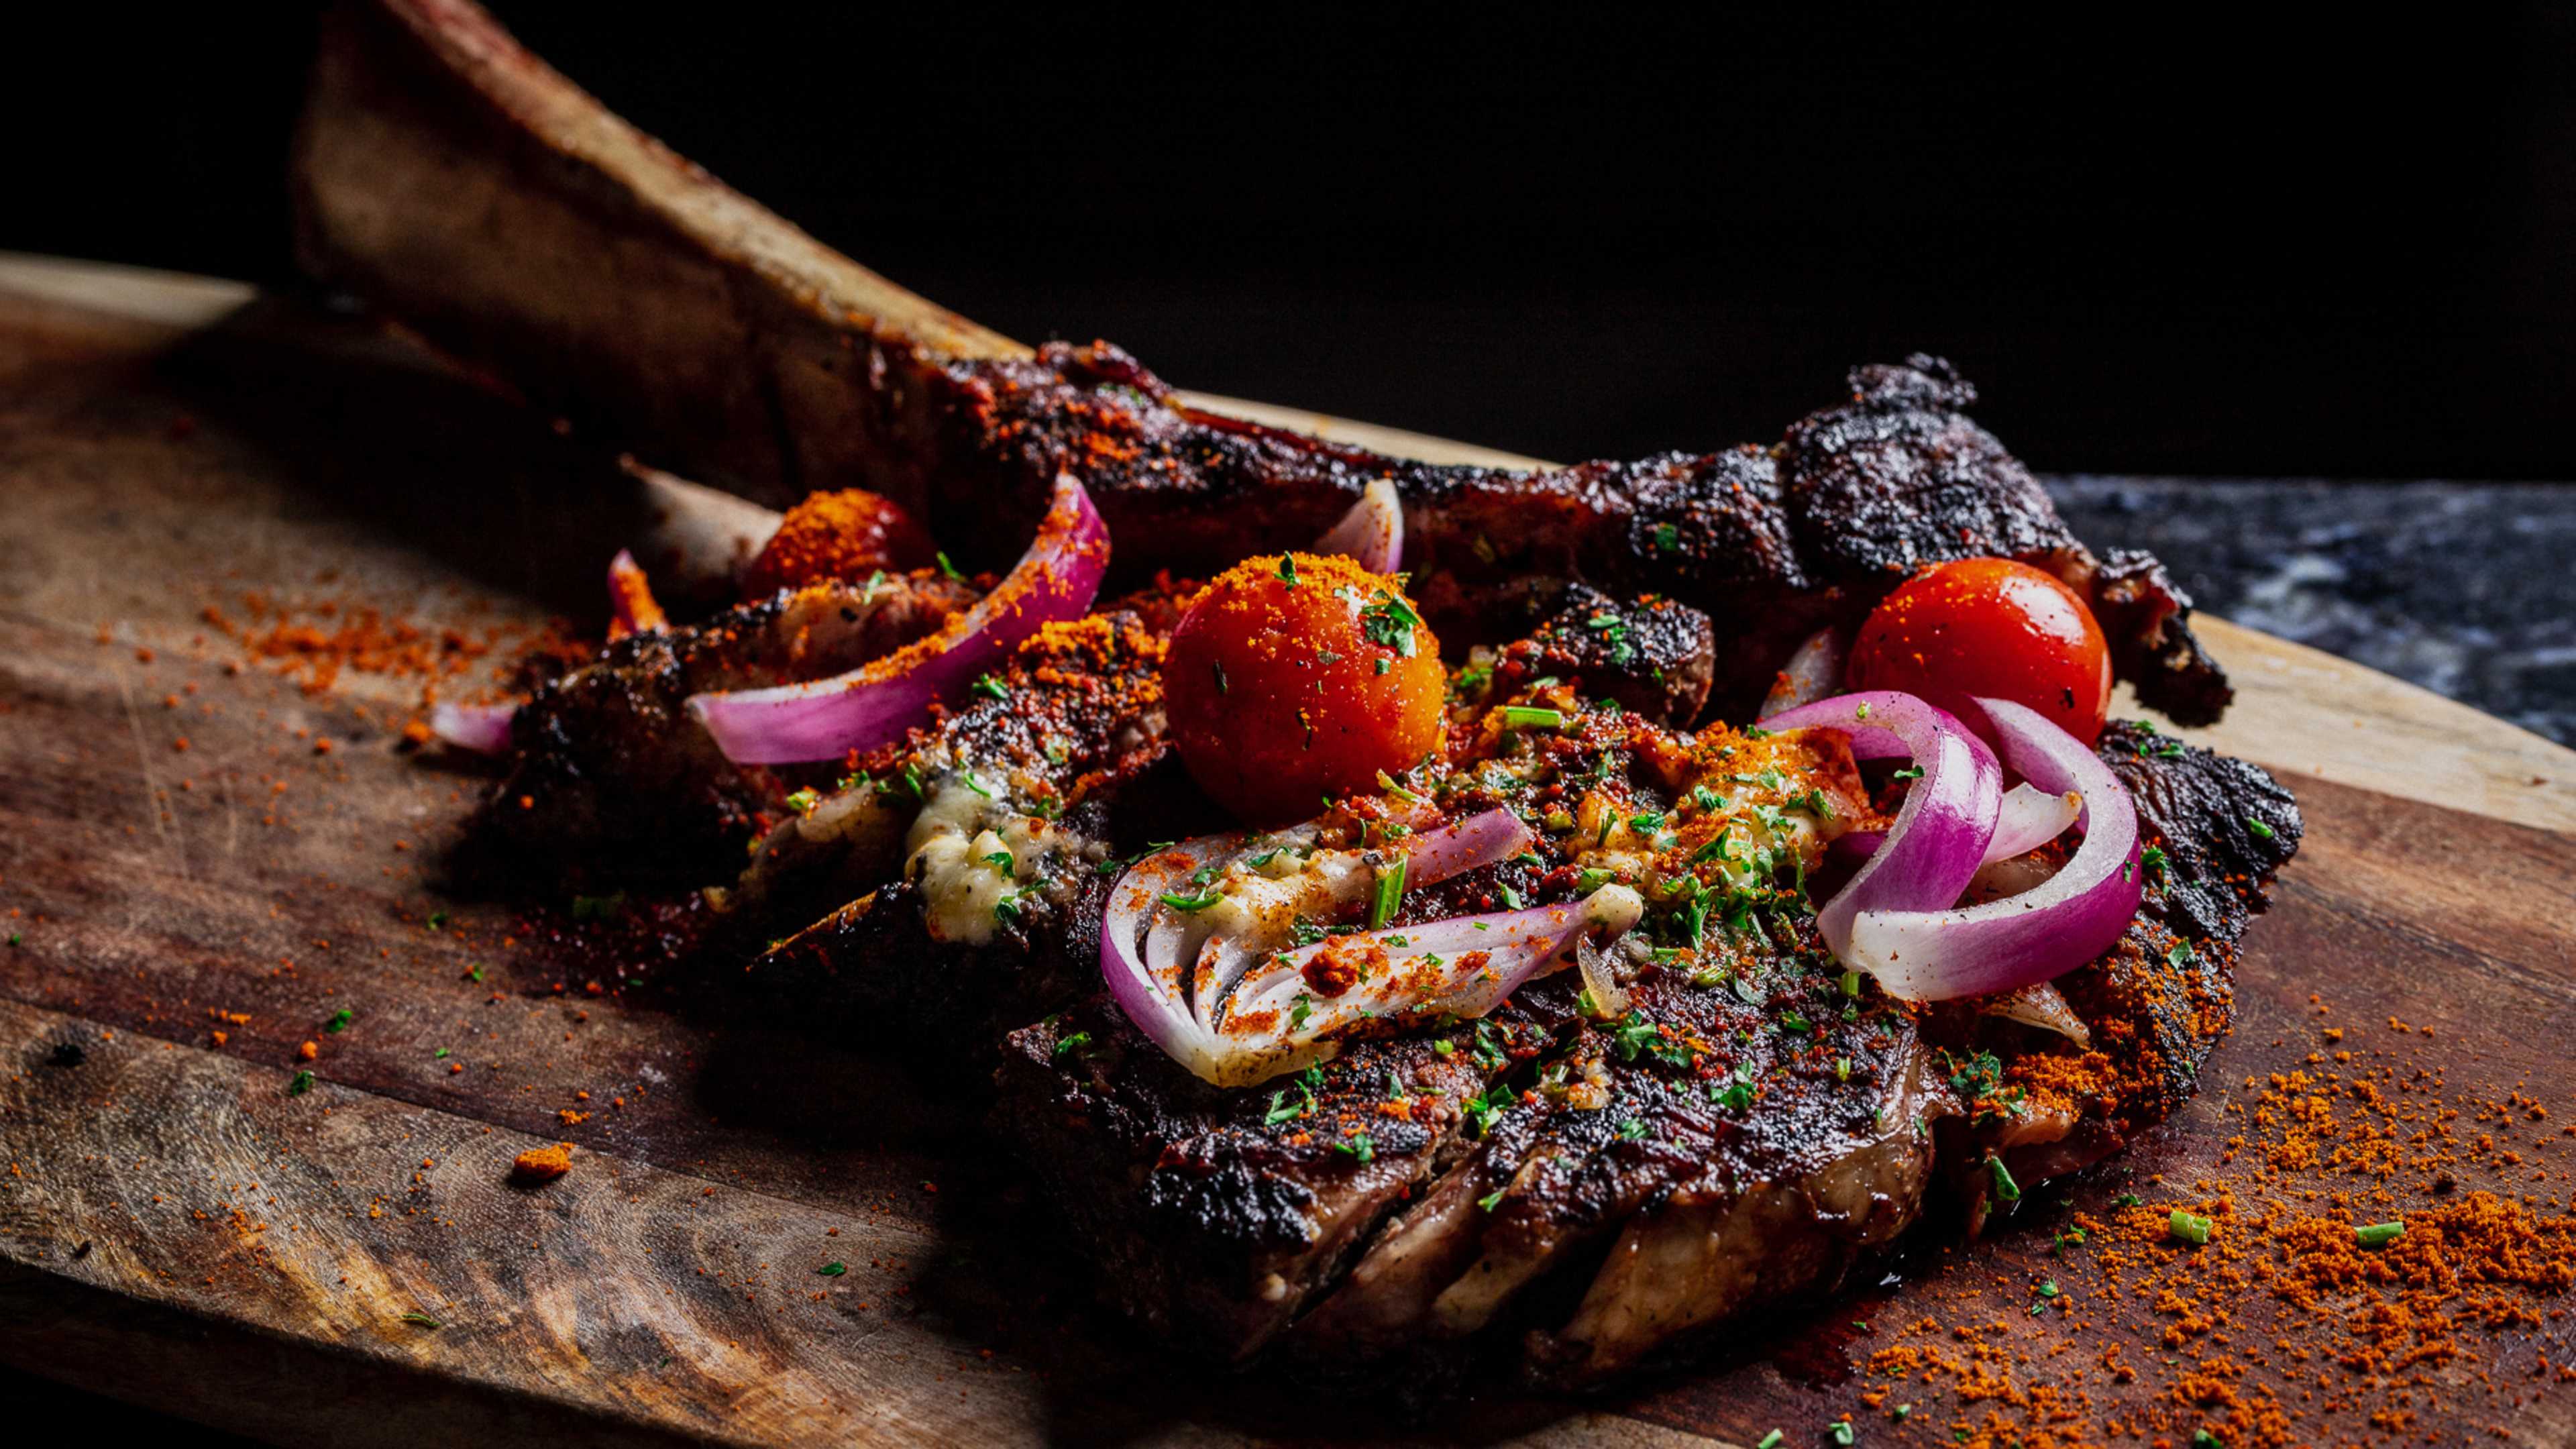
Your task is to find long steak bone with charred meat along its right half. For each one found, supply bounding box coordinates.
[294,0,2229,724]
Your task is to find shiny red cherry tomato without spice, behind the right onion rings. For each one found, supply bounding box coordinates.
[1847,559,2110,745]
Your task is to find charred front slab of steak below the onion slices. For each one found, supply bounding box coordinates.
[994,727,2298,1387]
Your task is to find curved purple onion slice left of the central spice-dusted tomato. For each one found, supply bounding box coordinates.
[688,474,1110,765]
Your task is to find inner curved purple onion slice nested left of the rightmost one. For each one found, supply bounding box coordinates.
[1762,688,2004,964]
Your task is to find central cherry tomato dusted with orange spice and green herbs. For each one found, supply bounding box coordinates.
[1162,554,1445,825]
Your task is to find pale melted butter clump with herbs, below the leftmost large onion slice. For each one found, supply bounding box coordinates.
[904,771,1100,947]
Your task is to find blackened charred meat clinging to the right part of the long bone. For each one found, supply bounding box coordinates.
[932,343,2229,724]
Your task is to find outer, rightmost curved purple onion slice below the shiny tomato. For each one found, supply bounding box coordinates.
[1834,699,2141,1000]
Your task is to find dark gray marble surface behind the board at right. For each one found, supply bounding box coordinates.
[2048,474,2576,745]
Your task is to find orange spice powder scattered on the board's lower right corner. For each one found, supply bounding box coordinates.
[1827,1006,2576,1449]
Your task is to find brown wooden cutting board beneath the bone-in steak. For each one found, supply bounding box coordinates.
[0,258,2576,1446]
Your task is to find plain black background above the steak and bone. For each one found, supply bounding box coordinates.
[0,0,2576,477]
